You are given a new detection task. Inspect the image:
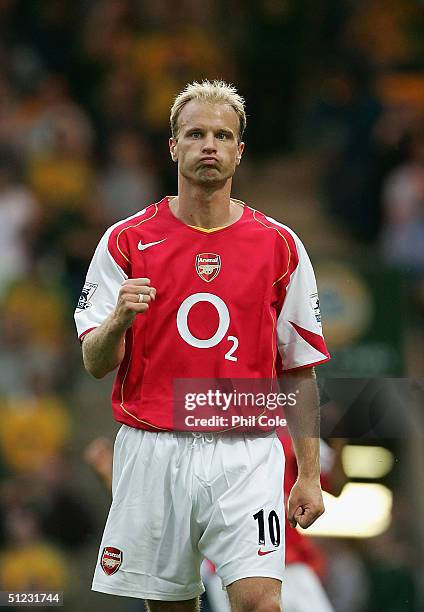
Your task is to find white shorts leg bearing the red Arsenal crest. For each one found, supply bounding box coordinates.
[93,426,203,609]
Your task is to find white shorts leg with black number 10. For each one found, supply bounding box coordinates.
[198,436,284,587]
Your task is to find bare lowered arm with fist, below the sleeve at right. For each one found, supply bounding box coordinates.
[283,367,324,529]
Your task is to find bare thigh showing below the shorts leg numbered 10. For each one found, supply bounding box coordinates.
[227,578,281,612]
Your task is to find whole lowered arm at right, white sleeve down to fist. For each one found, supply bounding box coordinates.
[277,228,330,528]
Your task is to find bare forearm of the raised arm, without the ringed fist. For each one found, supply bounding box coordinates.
[82,313,126,378]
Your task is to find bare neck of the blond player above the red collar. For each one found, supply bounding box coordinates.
[170,185,243,229]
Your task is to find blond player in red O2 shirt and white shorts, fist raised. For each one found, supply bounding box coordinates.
[75,81,329,612]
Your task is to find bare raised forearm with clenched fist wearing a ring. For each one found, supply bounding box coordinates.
[82,278,156,378]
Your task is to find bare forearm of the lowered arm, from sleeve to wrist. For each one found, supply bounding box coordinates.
[284,368,320,480]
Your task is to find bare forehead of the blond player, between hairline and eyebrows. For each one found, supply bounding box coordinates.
[178,100,239,133]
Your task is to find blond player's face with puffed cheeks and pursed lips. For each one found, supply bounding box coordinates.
[169,100,244,187]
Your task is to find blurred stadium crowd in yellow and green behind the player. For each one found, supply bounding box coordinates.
[0,0,424,612]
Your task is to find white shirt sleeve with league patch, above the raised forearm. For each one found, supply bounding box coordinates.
[75,229,128,338]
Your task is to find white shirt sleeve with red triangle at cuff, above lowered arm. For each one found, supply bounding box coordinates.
[277,231,330,370]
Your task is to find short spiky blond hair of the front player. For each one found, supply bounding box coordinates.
[170,80,246,142]
